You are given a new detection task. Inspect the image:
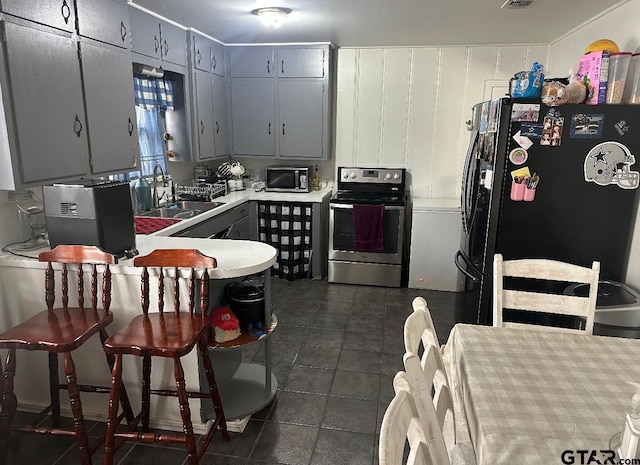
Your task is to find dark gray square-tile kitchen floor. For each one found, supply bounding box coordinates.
[7,278,461,465]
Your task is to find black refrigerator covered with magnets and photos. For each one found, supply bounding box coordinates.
[455,98,640,324]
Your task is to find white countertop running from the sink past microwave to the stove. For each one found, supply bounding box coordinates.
[152,188,331,236]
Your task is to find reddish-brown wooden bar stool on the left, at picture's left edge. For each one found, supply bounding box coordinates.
[0,245,133,465]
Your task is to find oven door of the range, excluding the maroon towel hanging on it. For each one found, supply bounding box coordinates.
[329,203,404,264]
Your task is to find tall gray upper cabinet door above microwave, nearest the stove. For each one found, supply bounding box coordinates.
[278,80,326,159]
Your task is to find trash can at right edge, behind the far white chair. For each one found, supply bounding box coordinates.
[565,281,640,339]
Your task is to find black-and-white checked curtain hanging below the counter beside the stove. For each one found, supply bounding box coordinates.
[258,202,313,281]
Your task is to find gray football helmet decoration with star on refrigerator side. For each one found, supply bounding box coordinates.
[584,141,640,189]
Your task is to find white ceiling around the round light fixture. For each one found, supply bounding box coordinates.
[129,0,627,47]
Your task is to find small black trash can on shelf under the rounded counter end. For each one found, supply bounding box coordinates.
[226,280,264,331]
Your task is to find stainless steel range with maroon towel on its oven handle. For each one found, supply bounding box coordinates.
[328,167,406,287]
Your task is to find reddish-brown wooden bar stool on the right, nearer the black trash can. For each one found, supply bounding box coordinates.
[104,249,229,465]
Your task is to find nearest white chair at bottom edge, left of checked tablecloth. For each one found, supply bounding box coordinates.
[378,371,438,465]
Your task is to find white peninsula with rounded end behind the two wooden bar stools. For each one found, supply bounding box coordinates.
[0,235,276,432]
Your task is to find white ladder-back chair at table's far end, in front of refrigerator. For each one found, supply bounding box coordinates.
[493,254,600,334]
